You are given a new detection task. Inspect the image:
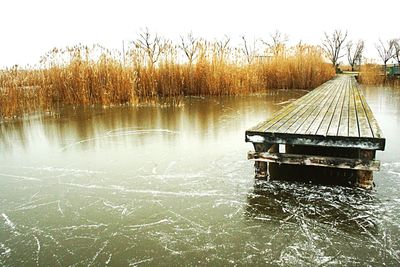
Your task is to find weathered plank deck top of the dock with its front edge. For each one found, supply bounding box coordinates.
[246,75,385,150]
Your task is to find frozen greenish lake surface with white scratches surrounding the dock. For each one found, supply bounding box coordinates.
[0,88,400,266]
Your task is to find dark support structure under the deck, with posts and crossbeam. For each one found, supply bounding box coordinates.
[248,144,380,189]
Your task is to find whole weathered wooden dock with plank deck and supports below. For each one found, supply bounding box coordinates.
[246,75,385,188]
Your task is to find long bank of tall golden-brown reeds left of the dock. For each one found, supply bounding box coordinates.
[0,39,334,119]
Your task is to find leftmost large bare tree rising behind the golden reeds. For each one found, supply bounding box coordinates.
[134,28,165,66]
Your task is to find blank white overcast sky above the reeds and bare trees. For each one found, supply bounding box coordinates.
[0,0,400,68]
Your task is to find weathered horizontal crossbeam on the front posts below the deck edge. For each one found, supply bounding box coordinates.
[248,151,380,171]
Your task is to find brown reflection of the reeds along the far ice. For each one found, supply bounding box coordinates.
[0,90,300,155]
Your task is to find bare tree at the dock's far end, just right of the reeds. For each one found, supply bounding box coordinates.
[322,30,347,68]
